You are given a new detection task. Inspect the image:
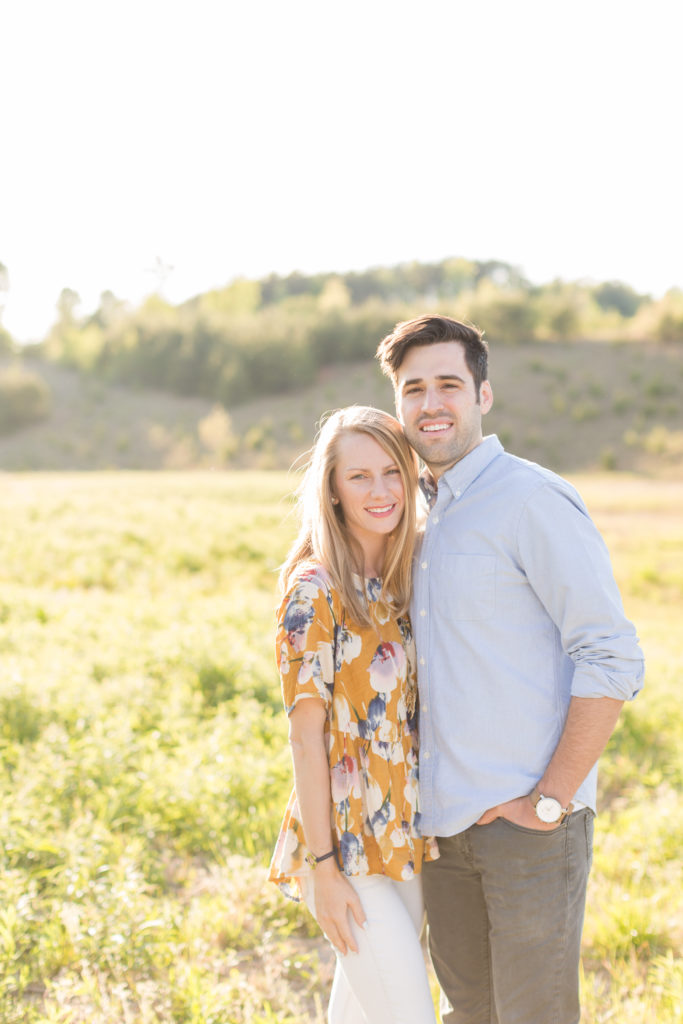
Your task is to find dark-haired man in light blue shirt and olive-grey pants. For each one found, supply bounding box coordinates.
[378,315,643,1024]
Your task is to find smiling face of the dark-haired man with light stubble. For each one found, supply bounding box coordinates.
[396,341,494,479]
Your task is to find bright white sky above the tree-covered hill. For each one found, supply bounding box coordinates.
[0,0,683,340]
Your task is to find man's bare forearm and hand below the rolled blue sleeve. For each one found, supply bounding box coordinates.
[477,697,624,831]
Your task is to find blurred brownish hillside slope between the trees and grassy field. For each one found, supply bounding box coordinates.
[0,342,683,475]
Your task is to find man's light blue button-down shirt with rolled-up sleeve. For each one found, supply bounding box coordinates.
[412,436,643,836]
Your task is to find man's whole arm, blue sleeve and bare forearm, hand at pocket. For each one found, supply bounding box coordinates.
[479,481,643,829]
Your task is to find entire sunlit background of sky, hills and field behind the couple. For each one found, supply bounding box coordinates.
[0,8,683,1024]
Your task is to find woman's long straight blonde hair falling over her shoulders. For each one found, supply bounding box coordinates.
[280,406,418,626]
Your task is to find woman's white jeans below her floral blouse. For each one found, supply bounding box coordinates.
[302,874,436,1024]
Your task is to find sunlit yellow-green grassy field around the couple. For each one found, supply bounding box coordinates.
[0,472,683,1024]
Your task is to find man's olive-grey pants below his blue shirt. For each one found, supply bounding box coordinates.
[423,808,593,1024]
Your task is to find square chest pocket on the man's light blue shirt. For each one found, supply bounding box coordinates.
[432,551,496,621]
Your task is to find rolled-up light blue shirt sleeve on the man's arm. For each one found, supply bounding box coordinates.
[517,480,644,700]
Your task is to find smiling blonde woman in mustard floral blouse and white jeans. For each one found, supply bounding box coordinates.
[270,407,438,1024]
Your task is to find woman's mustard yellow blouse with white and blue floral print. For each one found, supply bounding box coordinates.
[269,566,438,899]
